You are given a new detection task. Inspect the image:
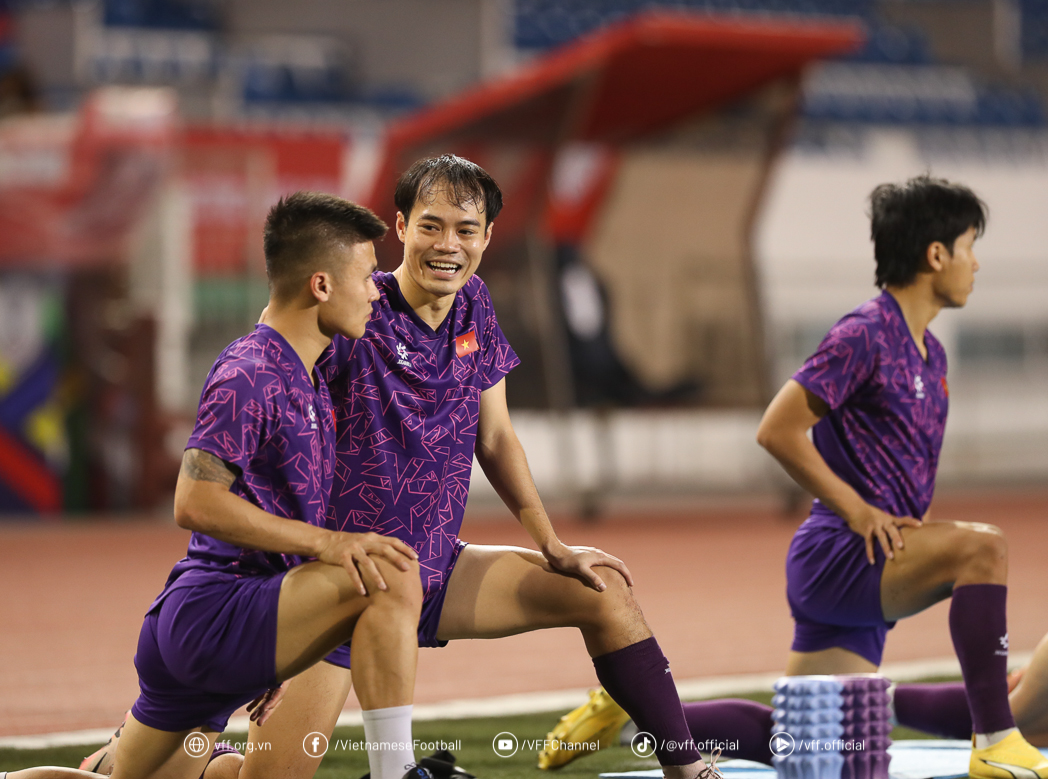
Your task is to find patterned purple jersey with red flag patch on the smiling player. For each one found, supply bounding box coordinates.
[316,273,520,594]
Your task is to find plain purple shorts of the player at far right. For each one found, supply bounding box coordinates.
[786,513,895,666]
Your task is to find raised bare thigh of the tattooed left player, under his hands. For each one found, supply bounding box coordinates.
[277,557,422,679]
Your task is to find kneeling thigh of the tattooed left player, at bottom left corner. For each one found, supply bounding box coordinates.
[112,714,217,779]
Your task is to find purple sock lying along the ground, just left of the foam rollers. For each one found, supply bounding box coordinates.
[684,698,772,765]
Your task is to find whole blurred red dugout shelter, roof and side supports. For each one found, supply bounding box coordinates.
[371,13,864,409]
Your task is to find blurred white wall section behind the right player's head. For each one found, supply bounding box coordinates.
[756,129,1048,377]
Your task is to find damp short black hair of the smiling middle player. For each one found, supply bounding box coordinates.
[393,154,502,229]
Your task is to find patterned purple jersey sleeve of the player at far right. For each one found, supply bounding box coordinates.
[793,317,879,409]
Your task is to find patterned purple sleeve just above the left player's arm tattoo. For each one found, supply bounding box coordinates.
[185,361,283,473]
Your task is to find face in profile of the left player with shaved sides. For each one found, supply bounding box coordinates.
[320,241,378,339]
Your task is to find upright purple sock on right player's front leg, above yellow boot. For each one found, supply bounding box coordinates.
[949,584,1016,733]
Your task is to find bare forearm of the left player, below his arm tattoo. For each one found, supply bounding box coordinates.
[175,479,329,557]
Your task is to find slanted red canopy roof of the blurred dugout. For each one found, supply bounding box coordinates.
[371,13,864,243]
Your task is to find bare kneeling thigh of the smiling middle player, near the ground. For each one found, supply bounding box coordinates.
[240,662,352,779]
